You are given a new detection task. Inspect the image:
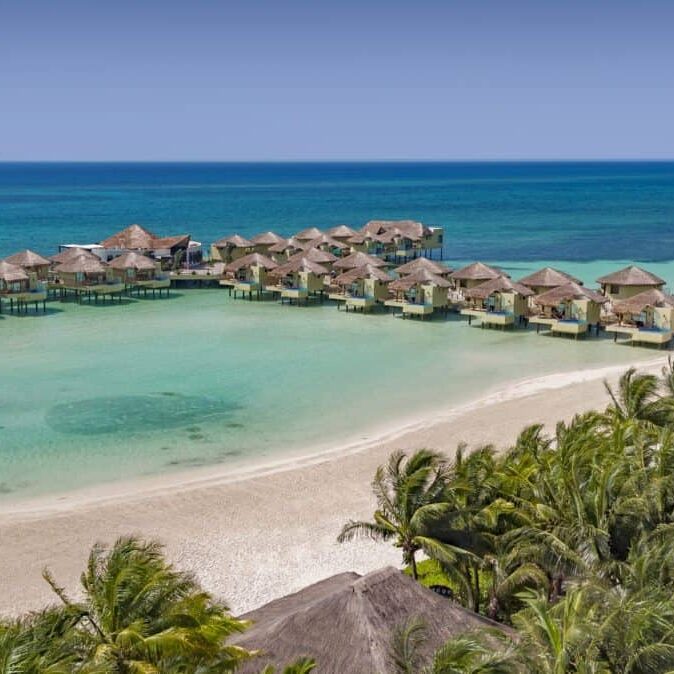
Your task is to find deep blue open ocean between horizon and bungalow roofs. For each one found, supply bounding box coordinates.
[0,162,674,262]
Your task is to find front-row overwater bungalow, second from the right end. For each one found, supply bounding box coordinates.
[529,282,608,338]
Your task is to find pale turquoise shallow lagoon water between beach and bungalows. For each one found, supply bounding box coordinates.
[0,262,674,500]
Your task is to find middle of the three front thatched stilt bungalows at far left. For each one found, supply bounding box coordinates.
[51,255,125,302]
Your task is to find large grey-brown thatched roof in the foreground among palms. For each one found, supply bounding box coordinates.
[232,567,508,674]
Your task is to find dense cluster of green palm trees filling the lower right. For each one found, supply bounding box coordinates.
[340,361,674,674]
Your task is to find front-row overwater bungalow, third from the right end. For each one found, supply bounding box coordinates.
[461,276,534,328]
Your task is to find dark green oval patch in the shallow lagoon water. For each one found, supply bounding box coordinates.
[45,393,240,435]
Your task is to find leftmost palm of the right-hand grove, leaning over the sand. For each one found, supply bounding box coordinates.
[337,449,472,579]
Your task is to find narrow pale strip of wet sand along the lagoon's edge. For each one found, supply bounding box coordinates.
[0,356,666,522]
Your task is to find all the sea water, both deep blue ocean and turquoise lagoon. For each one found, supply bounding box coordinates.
[0,162,674,501]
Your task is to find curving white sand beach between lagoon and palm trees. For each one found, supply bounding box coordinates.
[0,352,666,614]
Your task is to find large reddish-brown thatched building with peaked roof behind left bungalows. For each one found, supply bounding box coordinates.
[100,225,194,268]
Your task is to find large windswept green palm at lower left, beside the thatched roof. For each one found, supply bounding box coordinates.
[44,537,252,674]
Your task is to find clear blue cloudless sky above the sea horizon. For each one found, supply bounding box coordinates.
[0,0,674,160]
